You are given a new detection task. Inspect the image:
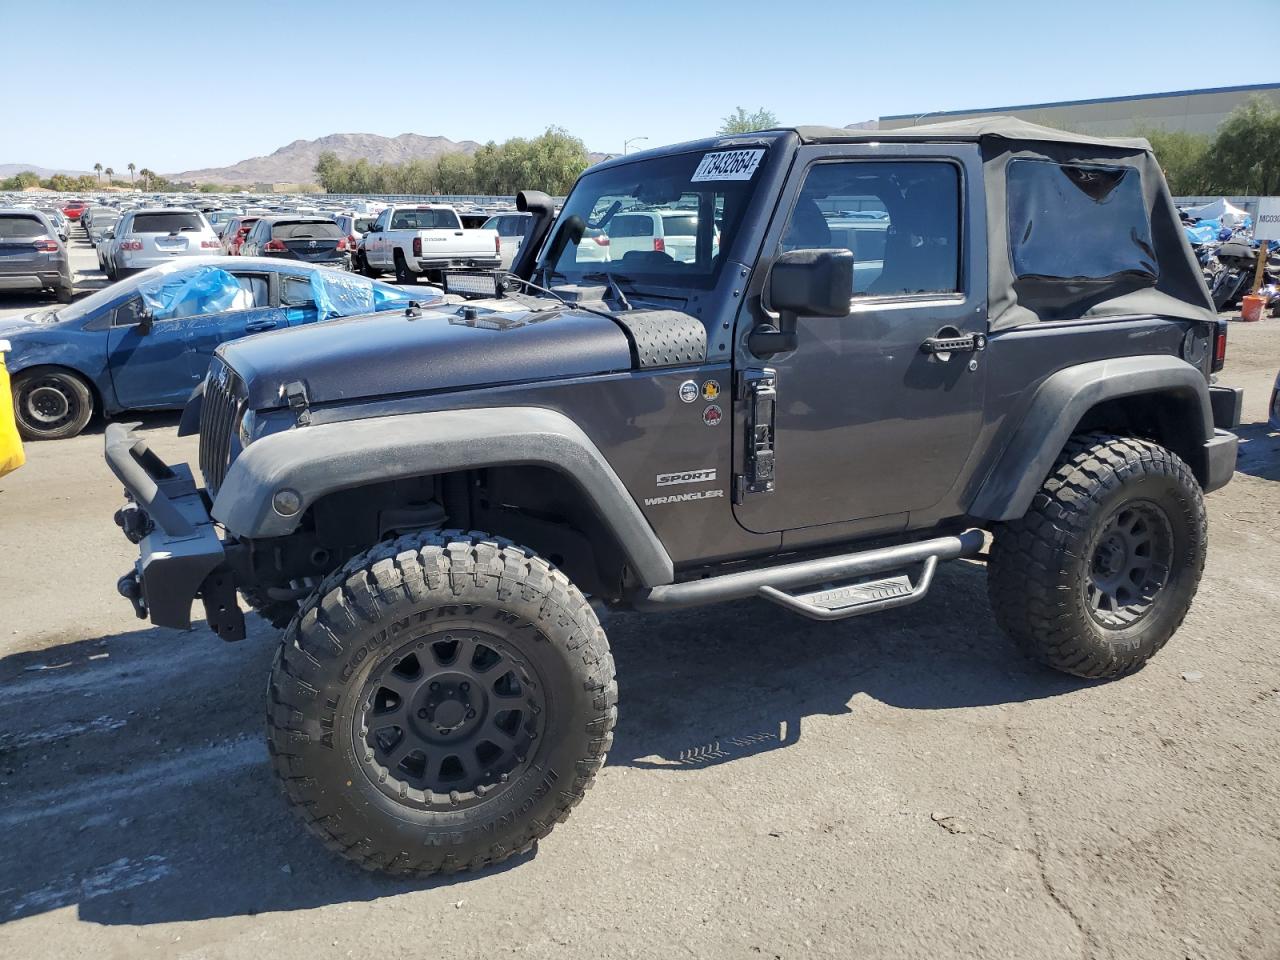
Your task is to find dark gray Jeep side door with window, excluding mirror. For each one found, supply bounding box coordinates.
[733,143,987,539]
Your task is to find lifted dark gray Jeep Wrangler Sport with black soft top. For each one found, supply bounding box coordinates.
[106,120,1240,874]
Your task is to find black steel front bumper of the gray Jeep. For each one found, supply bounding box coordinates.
[106,424,244,640]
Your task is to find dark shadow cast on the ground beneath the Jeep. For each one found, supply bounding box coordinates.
[0,563,1085,924]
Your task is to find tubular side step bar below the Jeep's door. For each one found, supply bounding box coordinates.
[632,530,984,620]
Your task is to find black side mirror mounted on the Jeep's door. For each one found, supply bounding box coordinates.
[746,250,854,358]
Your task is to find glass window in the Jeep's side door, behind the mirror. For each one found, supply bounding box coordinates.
[782,160,960,297]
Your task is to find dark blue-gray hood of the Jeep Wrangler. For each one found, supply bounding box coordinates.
[219,302,631,410]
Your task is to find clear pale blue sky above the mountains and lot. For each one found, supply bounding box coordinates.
[10,0,1280,173]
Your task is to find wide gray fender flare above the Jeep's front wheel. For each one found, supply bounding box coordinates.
[211,407,675,586]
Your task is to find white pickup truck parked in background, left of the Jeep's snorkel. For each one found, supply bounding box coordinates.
[357,204,502,283]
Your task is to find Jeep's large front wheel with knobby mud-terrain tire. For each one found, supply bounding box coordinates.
[268,531,617,876]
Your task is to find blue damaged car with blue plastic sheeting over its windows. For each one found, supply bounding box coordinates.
[0,257,432,440]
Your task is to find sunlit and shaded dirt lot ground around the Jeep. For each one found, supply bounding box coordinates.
[0,241,1280,960]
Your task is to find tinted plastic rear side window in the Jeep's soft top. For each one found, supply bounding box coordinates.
[1006,159,1160,285]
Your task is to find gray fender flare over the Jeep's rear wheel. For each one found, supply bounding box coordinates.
[969,355,1213,521]
